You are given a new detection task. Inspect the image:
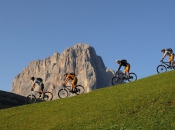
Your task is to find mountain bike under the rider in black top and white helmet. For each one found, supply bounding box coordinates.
[112,73,137,85]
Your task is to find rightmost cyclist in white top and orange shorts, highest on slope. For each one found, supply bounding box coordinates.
[161,48,175,68]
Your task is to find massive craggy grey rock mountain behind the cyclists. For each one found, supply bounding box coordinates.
[11,43,114,99]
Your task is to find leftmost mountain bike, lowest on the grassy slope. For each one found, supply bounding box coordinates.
[26,91,53,104]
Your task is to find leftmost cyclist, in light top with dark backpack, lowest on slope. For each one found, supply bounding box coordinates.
[30,77,44,97]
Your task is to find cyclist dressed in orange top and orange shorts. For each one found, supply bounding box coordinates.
[63,73,78,92]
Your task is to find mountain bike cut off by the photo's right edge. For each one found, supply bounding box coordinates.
[157,61,175,73]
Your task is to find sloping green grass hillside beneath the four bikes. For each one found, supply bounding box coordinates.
[0,71,175,130]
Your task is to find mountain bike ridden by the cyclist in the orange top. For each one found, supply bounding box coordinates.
[58,85,85,98]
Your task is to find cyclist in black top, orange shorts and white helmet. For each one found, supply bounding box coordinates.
[116,59,131,77]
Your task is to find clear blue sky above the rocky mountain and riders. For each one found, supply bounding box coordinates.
[0,0,175,92]
